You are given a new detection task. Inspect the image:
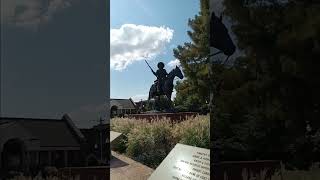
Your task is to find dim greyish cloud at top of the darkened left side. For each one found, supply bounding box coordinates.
[1,0,74,30]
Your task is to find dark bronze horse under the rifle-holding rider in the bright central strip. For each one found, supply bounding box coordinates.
[148,66,183,100]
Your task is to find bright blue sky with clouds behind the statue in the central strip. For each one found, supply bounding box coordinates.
[110,0,200,100]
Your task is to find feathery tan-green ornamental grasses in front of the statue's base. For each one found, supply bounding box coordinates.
[111,116,210,168]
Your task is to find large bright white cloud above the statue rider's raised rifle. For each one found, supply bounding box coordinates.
[110,24,174,71]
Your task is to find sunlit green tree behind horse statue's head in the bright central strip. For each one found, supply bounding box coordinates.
[173,0,210,111]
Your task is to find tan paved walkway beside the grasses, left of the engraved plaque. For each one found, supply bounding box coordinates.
[110,151,154,180]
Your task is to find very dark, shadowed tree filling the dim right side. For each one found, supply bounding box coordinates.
[214,0,320,168]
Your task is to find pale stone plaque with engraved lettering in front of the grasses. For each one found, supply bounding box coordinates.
[149,144,210,180]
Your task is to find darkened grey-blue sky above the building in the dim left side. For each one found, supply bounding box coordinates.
[0,0,109,128]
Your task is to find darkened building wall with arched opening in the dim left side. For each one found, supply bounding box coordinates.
[0,121,81,172]
